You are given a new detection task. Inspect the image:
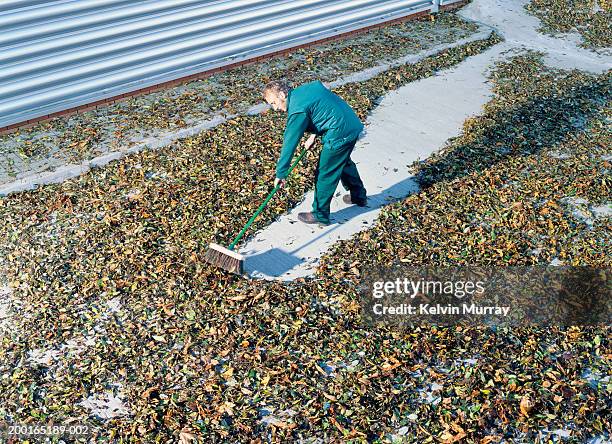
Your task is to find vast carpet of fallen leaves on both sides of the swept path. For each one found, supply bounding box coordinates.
[0,28,612,443]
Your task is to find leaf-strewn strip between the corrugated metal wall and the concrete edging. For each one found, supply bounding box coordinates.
[0,12,477,183]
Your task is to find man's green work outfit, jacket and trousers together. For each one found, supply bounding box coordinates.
[276,81,366,224]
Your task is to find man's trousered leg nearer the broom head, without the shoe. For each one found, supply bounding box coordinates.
[312,141,358,223]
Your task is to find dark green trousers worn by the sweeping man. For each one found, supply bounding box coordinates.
[312,140,366,224]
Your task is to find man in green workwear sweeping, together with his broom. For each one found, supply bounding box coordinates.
[204,82,367,274]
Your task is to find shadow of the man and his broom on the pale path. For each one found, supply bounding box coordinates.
[242,177,420,277]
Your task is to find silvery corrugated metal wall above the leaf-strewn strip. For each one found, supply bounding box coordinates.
[0,0,459,128]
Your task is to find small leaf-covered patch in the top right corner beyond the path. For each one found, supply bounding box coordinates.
[525,0,612,49]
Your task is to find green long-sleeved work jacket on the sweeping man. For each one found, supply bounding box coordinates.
[276,80,363,179]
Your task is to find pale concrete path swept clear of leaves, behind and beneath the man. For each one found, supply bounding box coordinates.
[239,0,612,280]
